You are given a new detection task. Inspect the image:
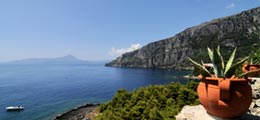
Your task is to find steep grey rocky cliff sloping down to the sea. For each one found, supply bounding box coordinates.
[106,7,260,68]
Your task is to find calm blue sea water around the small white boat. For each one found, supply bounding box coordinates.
[0,63,190,120]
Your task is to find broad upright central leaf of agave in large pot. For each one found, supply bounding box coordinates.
[212,47,224,77]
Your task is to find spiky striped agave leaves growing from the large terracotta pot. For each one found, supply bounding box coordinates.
[188,46,248,78]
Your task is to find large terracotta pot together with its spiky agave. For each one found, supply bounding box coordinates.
[188,47,258,118]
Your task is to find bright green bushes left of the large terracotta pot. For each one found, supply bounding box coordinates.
[96,82,199,120]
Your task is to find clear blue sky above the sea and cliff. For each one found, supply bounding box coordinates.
[0,0,260,61]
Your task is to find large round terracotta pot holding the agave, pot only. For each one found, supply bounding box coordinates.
[197,76,252,118]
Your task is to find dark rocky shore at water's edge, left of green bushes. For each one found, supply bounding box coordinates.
[52,104,100,120]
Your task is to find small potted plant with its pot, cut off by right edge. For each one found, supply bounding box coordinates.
[242,49,260,77]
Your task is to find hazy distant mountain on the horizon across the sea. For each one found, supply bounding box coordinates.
[7,55,89,64]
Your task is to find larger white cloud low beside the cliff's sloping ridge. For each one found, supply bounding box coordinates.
[109,43,142,55]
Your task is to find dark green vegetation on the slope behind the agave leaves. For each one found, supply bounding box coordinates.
[185,29,260,65]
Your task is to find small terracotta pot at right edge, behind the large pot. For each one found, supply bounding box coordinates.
[242,64,260,77]
